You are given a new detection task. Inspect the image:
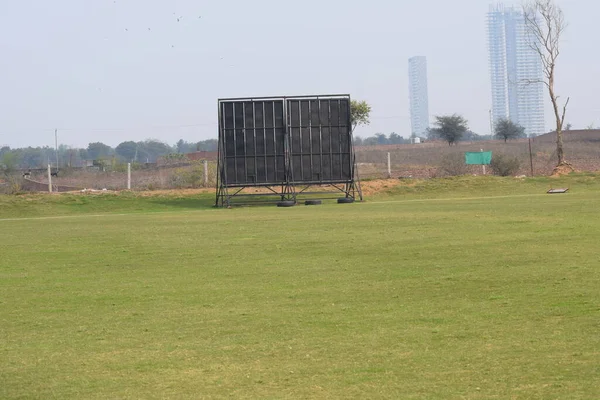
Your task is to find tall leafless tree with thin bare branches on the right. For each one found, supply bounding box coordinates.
[523,0,572,169]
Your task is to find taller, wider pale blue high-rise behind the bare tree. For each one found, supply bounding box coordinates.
[487,4,545,136]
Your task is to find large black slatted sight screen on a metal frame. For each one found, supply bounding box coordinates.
[216,95,362,206]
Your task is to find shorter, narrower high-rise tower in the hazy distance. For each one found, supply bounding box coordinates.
[408,57,429,136]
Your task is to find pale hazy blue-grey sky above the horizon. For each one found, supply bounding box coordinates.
[0,0,600,147]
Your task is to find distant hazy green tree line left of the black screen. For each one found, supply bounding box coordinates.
[0,139,218,168]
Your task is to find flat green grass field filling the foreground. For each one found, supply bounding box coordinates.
[0,175,600,399]
